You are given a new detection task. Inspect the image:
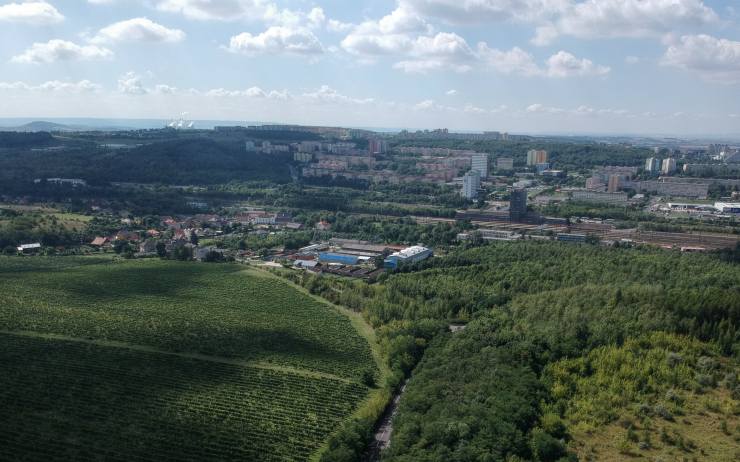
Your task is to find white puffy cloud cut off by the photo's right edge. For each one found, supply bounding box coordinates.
[661,34,740,83]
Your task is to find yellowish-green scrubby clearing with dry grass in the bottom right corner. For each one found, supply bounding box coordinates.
[545,332,740,462]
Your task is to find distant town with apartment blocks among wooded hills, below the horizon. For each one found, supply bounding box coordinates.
[5,124,740,268]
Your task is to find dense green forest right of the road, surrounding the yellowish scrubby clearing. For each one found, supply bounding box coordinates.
[278,242,740,461]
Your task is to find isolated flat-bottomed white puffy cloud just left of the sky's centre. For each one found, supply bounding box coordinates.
[227,26,324,55]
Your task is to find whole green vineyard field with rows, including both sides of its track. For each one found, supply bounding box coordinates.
[0,258,379,461]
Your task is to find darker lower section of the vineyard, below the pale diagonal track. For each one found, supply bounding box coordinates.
[0,335,366,461]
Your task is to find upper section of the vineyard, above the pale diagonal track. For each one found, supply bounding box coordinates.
[0,260,373,378]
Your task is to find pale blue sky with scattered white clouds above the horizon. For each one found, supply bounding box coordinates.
[0,0,740,136]
